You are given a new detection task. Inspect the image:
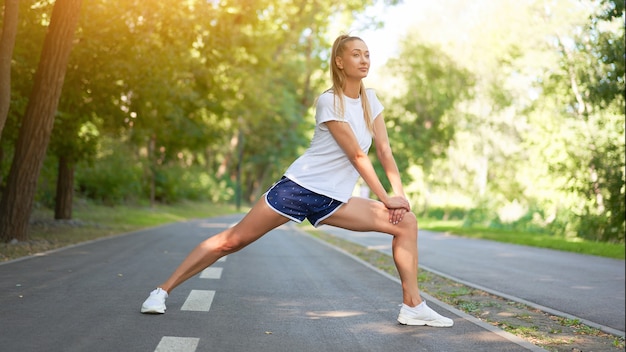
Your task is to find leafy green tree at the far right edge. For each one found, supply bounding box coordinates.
[543,0,626,242]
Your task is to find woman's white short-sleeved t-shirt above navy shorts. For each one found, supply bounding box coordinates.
[285,89,383,203]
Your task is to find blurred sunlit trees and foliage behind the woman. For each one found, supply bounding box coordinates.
[0,0,625,243]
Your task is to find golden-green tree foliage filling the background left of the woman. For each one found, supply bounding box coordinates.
[2,0,388,228]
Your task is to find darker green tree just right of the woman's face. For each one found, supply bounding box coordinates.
[386,38,474,184]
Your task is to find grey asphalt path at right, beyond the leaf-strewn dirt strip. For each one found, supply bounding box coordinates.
[320,226,626,336]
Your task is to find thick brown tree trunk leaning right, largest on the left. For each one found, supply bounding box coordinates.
[0,0,82,241]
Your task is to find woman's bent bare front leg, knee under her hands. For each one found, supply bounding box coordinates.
[321,197,422,307]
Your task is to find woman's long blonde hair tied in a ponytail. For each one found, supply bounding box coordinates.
[330,34,374,136]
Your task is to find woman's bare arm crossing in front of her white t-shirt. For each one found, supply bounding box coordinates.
[326,121,411,214]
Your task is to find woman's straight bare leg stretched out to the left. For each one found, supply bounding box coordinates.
[159,199,289,292]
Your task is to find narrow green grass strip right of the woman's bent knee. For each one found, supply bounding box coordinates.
[420,219,626,259]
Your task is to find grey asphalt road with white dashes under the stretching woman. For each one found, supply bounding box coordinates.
[0,217,540,352]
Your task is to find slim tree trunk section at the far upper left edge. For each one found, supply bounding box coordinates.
[0,0,20,136]
